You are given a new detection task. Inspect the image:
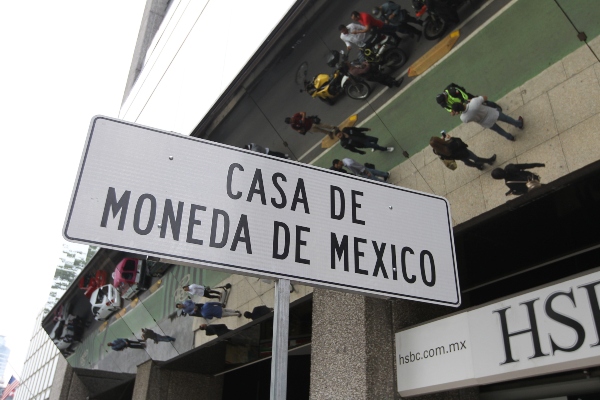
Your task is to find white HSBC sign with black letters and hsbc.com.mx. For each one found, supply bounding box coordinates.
[396,271,600,396]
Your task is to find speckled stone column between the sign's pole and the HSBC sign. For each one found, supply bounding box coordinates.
[310,289,395,400]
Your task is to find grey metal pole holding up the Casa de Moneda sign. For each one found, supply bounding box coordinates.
[271,279,290,400]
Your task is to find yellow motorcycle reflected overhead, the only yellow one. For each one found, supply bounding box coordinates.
[300,59,371,105]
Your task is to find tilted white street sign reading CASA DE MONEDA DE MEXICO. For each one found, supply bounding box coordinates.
[64,116,460,306]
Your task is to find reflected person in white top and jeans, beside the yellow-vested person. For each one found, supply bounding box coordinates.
[452,96,525,142]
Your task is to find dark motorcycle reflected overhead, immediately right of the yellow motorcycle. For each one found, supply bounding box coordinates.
[360,34,408,73]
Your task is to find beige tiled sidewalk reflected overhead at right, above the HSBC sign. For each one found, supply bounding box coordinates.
[390,37,600,225]
